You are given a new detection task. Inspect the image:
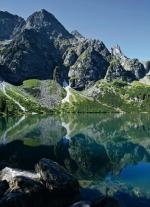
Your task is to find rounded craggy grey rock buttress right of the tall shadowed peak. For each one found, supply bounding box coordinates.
[68,40,111,89]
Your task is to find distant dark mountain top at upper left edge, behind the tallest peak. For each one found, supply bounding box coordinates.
[0,11,25,41]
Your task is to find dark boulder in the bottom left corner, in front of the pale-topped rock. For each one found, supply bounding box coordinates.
[0,176,47,207]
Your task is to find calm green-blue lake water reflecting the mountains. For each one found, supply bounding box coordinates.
[0,113,150,207]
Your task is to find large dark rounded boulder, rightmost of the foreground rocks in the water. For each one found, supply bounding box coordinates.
[36,159,79,194]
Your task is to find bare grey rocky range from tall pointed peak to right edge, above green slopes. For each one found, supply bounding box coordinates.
[0,9,150,87]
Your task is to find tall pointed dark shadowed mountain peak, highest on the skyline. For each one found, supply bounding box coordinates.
[0,10,73,84]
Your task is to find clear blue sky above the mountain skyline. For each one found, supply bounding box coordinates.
[0,0,150,60]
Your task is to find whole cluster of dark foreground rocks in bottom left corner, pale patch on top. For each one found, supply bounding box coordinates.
[0,159,79,207]
